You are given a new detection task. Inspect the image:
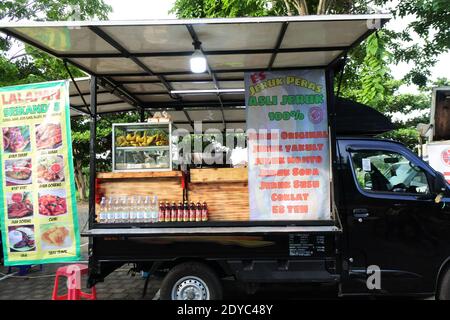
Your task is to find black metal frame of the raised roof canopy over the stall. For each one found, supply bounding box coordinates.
[0,14,390,128]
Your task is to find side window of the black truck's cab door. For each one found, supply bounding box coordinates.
[351,150,430,194]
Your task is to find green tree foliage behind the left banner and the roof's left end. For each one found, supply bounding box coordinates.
[0,0,112,200]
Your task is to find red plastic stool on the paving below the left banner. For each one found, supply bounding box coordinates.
[52,264,97,300]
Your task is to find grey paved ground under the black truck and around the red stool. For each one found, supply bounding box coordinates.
[0,205,434,300]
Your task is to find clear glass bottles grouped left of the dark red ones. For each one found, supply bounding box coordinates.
[99,195,158,223]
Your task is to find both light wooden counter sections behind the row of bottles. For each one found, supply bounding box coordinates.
[97,168,249,221]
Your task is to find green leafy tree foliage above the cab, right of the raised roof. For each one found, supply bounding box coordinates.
[172,0,444,152]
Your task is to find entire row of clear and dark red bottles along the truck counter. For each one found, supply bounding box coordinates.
[97,195,208,223]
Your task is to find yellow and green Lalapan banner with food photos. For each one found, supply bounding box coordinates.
[0,81,80,265]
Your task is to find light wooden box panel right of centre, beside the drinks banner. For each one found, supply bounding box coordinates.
[188,168,250,221]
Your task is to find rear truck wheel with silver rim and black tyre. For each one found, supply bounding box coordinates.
[160,262,222,300]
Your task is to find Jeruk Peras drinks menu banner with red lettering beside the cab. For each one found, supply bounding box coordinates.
[245,69,330,221]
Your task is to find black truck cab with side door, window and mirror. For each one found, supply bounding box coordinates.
[336,137,450,294]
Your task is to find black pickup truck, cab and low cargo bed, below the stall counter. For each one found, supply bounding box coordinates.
[89,137,450,300]
